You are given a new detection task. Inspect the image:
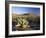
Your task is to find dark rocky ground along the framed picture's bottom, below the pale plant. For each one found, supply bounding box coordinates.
[12,24,40,31]
